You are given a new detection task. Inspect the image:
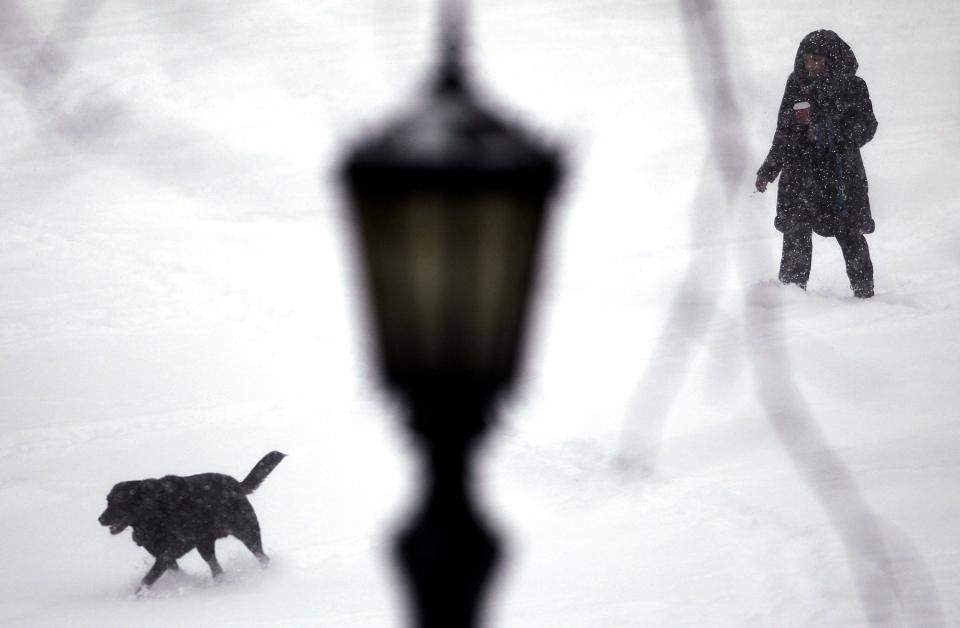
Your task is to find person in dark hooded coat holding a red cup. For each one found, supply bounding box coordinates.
[756,30,877,298]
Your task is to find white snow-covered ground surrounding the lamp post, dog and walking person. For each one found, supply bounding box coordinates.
[0,0,960,628]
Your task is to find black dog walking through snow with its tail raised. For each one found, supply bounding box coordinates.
[100,451,285,593]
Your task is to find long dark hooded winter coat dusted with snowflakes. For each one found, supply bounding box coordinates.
[757,30,877,236]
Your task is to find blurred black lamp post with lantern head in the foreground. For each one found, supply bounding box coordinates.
[343,2,560,628]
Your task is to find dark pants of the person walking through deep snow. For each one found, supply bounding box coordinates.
[780,231,873,297]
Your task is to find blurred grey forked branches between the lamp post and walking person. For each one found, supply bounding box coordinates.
[621,0,944,626]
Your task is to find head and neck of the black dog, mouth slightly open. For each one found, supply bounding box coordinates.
[99,476,182,534]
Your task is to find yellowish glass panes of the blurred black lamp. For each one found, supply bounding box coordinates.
[360,191,542,381]
